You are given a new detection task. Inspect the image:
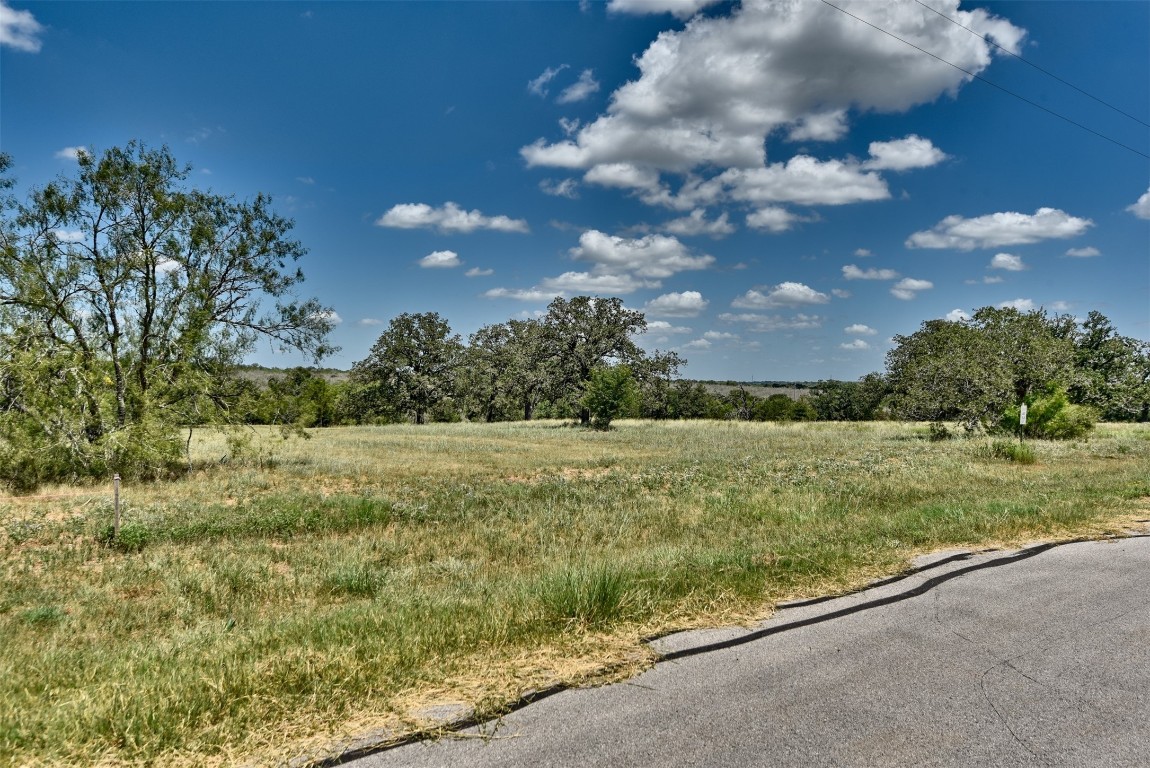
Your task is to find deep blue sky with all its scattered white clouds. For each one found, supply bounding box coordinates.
[0,0,1150,381]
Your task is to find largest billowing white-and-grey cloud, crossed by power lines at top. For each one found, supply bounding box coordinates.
[522,0,1025,172]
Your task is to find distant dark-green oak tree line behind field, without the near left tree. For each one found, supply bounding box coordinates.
[238,297,1150,437]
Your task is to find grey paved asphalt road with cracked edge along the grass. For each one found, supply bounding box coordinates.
[347,538,1150,768]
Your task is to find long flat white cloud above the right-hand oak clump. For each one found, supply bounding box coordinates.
[906,208,1094,251]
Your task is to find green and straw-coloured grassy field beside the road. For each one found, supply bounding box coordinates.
[0,422,1150,765]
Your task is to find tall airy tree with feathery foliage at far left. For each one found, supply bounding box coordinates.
[0,141,332,489]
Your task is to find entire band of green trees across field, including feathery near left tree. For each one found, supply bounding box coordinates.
[0,141,1150,490]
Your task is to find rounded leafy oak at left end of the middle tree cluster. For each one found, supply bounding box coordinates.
[351,312,463,424]
